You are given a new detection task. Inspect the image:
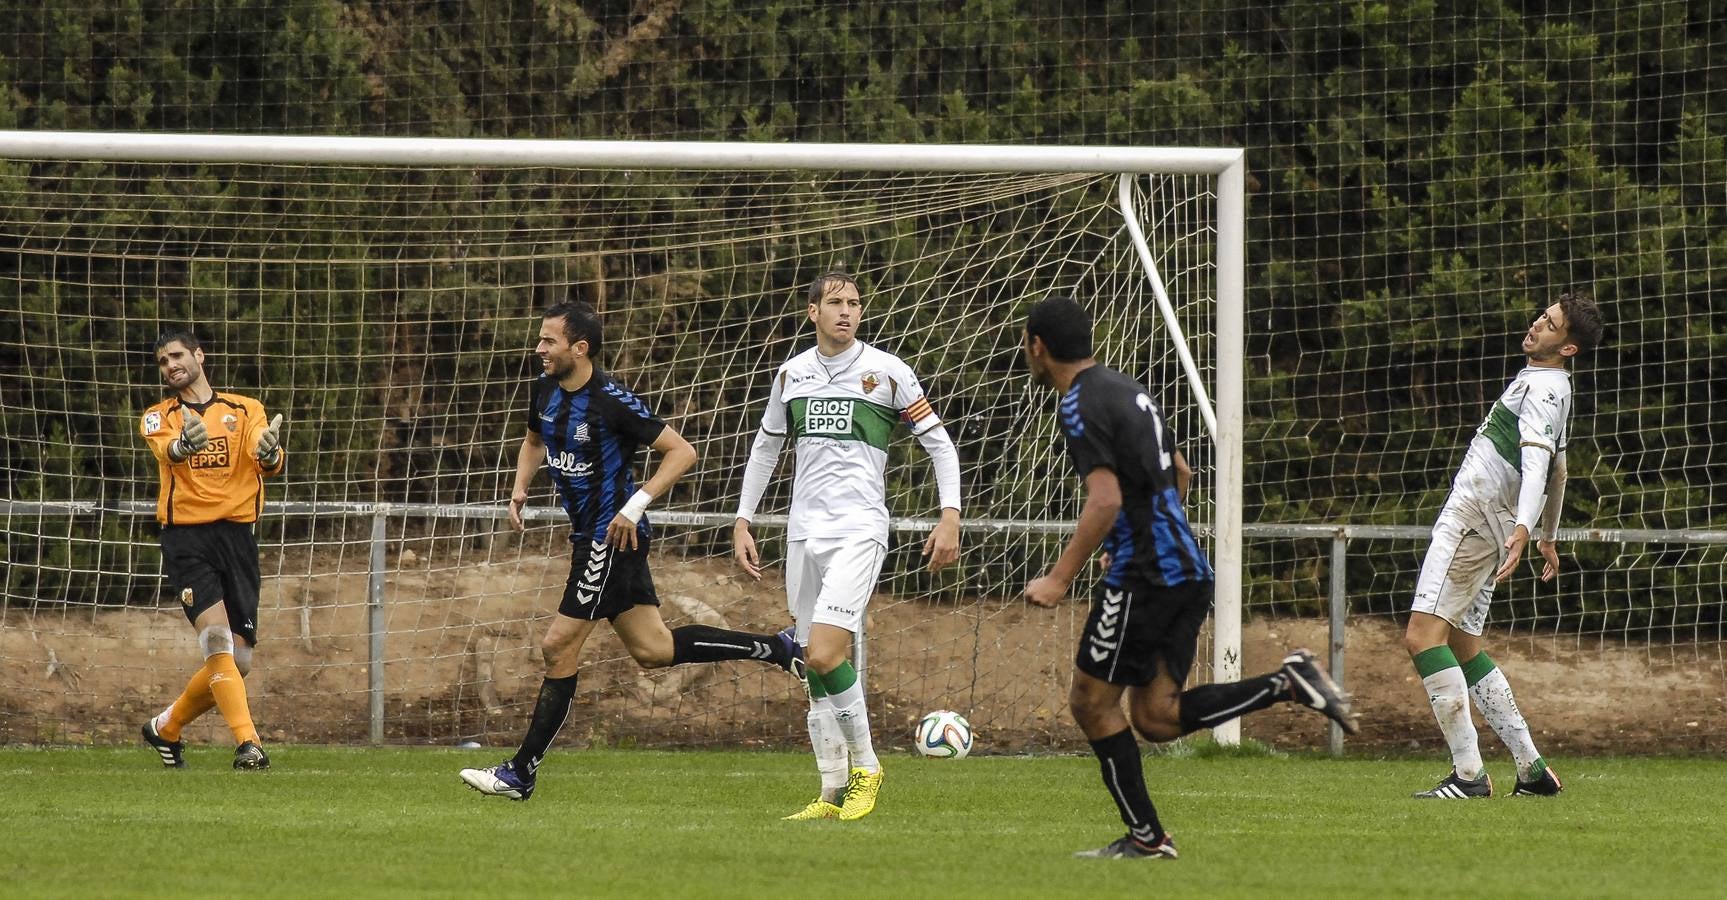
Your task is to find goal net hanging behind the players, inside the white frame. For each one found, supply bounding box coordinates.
[0,135,1242,750]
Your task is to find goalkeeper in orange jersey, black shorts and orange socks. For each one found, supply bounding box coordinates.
[138,332,287,769]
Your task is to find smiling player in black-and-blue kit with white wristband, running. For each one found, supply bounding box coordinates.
[461,302,800,800]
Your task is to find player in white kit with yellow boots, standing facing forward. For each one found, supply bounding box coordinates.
[732,273,960,821]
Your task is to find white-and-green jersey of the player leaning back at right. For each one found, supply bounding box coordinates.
[1451,366,1572,511]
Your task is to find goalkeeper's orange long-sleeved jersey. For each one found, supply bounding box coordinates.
[138,390,288,525]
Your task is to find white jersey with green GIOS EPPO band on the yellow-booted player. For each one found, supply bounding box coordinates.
[762,340,941,546]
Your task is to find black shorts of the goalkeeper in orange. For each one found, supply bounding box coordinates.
[162,520,261,646]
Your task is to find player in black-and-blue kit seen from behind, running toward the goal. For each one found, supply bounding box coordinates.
[1024,297,1356,859]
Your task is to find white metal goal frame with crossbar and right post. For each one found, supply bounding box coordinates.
[0,131,1247,743]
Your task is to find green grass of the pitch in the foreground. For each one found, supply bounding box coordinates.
[0,746,1727,900]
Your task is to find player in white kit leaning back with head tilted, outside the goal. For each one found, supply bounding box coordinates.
[1404,294,1601,800]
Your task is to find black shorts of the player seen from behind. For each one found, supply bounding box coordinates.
[1074,580,1212,686]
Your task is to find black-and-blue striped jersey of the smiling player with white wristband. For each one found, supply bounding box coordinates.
[527,368,665,544]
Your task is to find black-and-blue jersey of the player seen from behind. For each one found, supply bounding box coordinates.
[1060,366,1216,587]
